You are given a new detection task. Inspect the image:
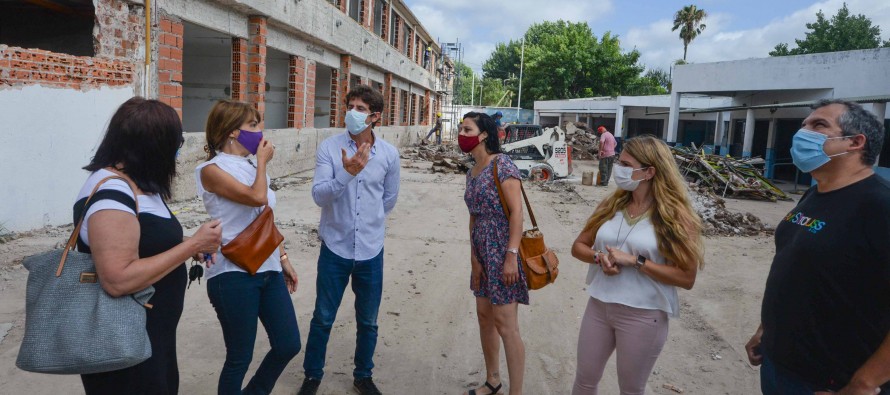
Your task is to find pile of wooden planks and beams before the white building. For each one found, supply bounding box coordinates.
[671,146,791,202]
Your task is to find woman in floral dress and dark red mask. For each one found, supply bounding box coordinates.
[458,112,528,395]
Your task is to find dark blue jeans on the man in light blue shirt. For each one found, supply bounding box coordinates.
[303,244,383,380]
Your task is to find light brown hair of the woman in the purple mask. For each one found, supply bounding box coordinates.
[204,100,262,160]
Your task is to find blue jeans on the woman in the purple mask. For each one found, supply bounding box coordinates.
[207,271,300,395]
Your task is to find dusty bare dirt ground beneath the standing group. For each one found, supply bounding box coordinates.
[0,160,797,395]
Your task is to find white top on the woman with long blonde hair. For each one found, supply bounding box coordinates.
[587,211,680,317]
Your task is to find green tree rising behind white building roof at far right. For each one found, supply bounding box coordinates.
[769,3,890,56]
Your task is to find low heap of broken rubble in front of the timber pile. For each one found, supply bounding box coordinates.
[689,183,773,236]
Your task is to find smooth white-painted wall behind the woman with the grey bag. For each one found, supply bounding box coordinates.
[0,85,134,231]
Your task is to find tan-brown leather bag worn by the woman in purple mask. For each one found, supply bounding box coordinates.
[221,205,284,276]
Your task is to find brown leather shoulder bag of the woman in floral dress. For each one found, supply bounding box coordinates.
[494,158,559,289]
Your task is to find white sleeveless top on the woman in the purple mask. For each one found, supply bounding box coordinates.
[195,152,281,280]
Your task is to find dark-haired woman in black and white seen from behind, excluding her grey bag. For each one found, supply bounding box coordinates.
[74,97,221,395]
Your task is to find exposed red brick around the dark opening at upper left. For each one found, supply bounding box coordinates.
[0,0,138,89]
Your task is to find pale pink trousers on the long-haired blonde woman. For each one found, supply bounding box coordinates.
[572,298,668,395]
